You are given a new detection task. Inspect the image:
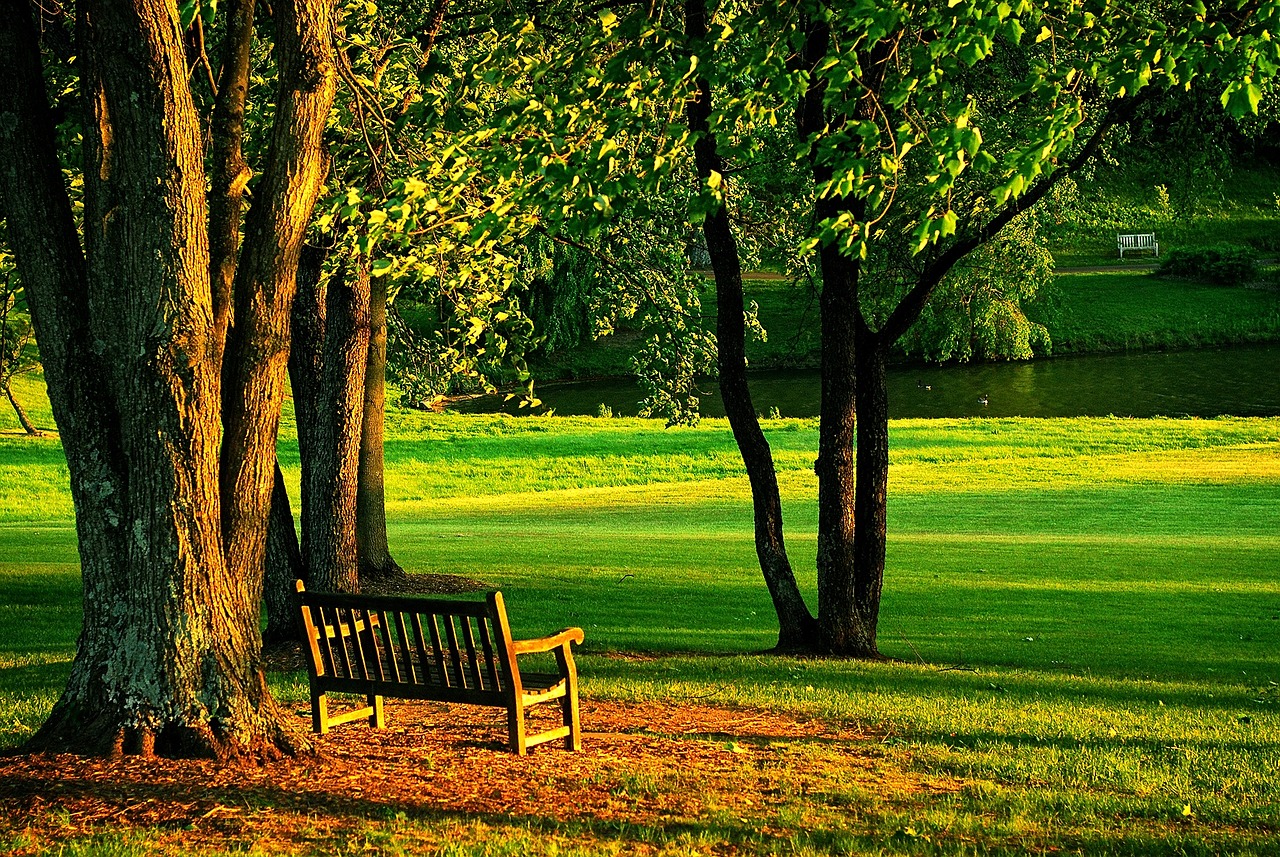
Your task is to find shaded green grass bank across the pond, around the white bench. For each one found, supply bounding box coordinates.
[540,162,1280,380]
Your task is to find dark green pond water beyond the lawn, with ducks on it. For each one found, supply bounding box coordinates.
[456,344,1280,418]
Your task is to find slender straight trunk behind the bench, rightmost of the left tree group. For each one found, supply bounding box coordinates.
[356,272,401,579]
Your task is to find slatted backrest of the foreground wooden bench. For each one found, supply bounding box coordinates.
[297,581,518,705]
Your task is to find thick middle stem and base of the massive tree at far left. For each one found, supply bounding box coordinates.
[3,3,287,755]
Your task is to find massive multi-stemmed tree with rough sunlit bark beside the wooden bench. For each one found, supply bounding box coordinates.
[0,0,334,757]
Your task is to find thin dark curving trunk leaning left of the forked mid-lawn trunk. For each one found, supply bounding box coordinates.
[685,0,818,651]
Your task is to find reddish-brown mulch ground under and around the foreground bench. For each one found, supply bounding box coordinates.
[0,700,955,853]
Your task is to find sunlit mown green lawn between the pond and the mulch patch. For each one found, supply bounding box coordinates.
[0,390,1280,854]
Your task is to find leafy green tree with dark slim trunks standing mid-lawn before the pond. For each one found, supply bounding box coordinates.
[490,0,1280,657]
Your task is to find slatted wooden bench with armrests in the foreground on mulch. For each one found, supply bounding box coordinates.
[297,581,582,756]
